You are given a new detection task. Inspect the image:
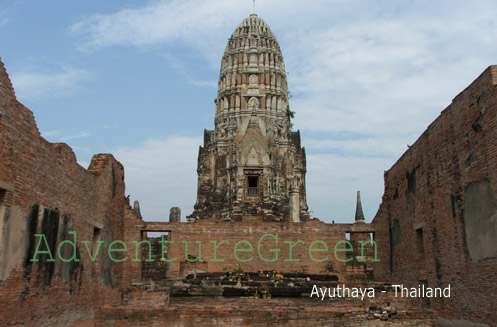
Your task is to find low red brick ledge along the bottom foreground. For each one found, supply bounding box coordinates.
[95,298,437,327]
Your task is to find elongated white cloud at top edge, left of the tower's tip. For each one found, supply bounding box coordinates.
[71,0,247,64]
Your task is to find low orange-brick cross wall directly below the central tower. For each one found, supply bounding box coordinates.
[127,219,381,282]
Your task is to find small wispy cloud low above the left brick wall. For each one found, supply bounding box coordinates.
[11,67,92,100]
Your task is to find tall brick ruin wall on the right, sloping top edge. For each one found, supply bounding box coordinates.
[373,66,497,326]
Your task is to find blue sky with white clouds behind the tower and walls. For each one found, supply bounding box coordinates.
[0,0,497,222]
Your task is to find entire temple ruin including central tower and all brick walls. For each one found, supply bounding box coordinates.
[0,15,497,326]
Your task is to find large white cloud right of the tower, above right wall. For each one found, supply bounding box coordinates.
[285,4,497,140]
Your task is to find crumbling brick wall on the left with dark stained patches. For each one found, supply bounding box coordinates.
[0,57,142,326]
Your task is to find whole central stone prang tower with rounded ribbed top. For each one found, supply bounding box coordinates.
[188,14,308,222]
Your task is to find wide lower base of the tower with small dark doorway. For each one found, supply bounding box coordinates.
[191,126,309,222]
